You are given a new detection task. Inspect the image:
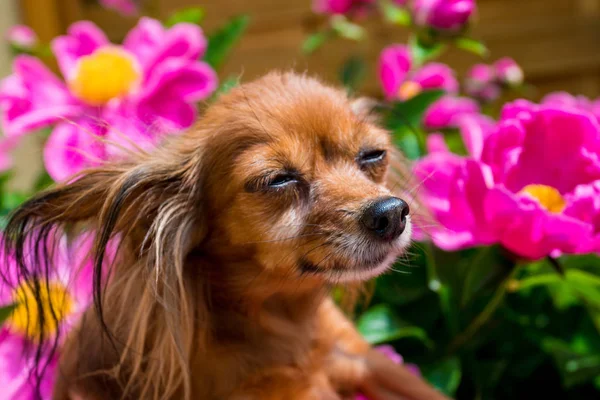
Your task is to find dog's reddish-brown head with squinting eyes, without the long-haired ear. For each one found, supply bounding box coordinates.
[197,74,411,282]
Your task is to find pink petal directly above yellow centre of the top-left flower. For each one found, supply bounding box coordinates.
[51,21,110,79]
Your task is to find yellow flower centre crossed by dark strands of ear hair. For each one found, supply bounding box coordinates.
[7,281,73,338]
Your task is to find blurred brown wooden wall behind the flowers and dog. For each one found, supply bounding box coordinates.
[20,0,600,97]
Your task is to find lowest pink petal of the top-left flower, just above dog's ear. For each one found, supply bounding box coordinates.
[44,119,106,182]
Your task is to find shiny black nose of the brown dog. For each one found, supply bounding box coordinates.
[360,197,410,240]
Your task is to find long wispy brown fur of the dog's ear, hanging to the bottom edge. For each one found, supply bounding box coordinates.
[0,141,205,398]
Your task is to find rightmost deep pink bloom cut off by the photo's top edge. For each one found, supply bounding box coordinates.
[413,0,475,31]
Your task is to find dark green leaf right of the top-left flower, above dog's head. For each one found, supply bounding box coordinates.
[204,15,250,69]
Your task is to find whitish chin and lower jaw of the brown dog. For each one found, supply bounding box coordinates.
[299,219,411,284]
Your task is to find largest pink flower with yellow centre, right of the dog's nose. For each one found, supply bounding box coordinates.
[415,101,600,259]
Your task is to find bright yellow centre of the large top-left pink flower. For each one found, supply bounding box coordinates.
[68,46,141,105]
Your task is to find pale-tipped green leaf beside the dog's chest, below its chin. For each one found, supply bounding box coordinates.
[357,304,432,346]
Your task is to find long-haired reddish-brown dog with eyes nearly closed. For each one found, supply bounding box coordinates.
[5,72,445,400]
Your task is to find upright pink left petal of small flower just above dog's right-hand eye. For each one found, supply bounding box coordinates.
[379,45,412,99]
